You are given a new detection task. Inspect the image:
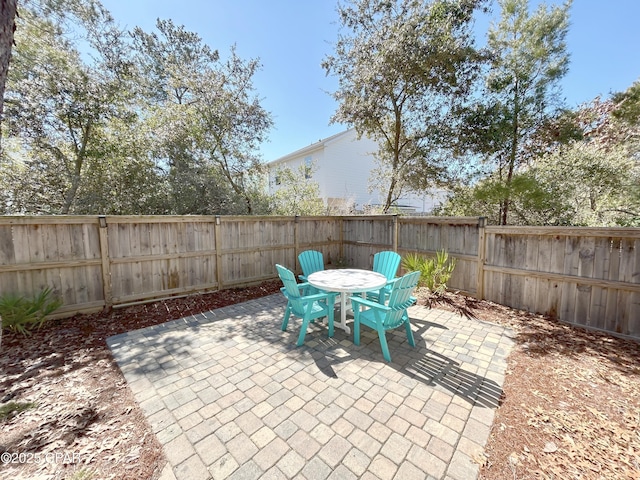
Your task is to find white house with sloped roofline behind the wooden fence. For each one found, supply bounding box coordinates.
[266,128,445,213]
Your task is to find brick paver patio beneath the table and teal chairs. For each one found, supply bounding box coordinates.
[108,295,512,480]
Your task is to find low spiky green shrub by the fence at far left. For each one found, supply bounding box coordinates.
[0,288,62,335]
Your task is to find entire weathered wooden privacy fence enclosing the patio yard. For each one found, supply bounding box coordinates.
[0,216,640,339]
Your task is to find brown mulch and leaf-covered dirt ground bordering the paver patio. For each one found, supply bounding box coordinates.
[0,280,640,480]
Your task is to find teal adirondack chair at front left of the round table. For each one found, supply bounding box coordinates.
[276,264,337,347]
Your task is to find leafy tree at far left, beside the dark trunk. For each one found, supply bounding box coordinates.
[3,2,136,214]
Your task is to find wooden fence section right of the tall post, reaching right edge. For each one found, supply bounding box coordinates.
[477,227,640,338]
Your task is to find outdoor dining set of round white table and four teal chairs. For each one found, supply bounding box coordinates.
[276,250,420,362]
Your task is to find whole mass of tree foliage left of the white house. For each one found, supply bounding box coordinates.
[0,0,272,214]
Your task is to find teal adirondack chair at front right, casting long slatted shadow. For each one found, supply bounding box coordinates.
[351,272,420,362]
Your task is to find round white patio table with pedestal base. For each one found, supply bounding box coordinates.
[307,268,387,334]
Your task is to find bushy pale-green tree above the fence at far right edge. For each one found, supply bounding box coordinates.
[530,91,640,226]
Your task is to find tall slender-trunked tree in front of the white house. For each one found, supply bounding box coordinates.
[323,0,482,212]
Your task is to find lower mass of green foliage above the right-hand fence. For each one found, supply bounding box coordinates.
[441,87,640,226]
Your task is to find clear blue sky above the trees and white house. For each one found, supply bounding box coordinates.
[102,0,640,161]
